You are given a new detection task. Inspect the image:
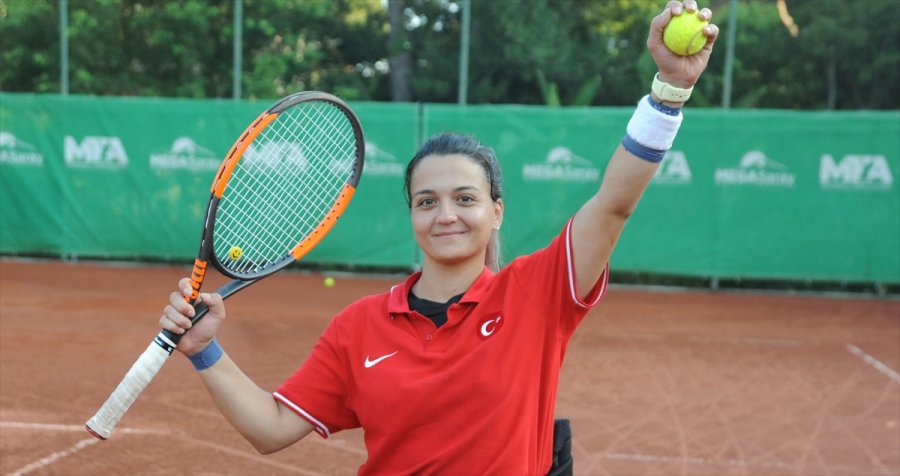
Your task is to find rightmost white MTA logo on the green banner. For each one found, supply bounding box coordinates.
[819,154,894,190]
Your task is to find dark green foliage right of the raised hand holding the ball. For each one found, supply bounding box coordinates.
[705,0,900,109]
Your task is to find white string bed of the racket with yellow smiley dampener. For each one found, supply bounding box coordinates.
[214,101,358,273]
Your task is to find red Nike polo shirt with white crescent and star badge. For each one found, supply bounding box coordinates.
[274,220,608,475]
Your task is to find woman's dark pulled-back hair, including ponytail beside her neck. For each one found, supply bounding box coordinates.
[403,133,503,272]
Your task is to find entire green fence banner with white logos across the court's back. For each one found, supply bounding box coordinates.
[0,93,900,283]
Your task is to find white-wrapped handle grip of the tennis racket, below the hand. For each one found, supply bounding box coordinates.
[84,332,174,440]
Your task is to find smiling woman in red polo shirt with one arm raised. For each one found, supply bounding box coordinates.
[160,0,718,474]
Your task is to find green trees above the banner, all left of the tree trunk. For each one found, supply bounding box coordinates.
[0,0,386,99]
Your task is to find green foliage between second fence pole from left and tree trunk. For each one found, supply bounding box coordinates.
[244,0,387,99]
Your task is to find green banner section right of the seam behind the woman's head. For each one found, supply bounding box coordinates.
[425,105,900,283]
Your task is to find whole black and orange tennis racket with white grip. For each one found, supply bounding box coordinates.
[85,91,365,440]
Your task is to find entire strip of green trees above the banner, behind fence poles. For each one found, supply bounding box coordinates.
[0,0,900,109]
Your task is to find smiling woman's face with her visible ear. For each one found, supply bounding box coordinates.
[409,154,503,266]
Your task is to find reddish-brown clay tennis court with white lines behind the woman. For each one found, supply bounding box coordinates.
[0,259,900,475]
